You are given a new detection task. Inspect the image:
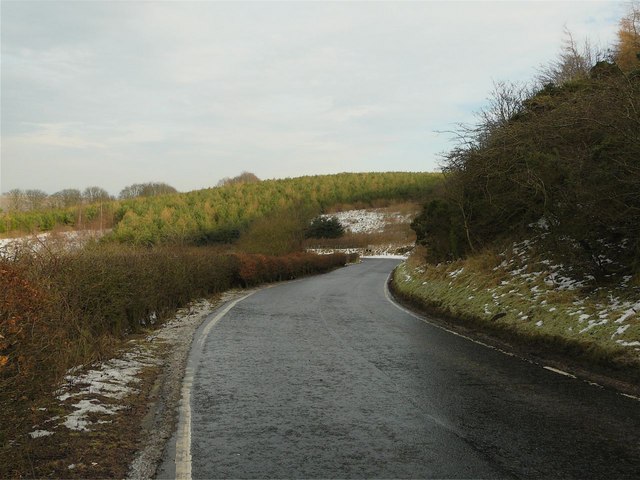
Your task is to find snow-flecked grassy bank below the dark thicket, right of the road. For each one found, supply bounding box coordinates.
[392,246,640,381]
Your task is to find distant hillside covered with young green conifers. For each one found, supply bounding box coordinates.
[0,173,442,245]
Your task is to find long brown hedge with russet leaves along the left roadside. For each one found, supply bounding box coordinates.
[0,244,356,462]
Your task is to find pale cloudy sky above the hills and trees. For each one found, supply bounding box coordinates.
[0,0,626,195]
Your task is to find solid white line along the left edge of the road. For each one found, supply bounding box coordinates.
[176,290,257,480]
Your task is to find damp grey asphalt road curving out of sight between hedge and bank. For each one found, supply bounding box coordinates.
[160,259,640,479]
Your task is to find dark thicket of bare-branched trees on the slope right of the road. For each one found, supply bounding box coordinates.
[428,57,640,278]
